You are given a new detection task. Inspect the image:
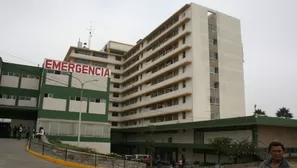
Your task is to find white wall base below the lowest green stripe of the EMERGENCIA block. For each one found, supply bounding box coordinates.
[62,141,110,153]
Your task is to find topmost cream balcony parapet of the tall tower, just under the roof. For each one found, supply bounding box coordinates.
[124,15,190,64]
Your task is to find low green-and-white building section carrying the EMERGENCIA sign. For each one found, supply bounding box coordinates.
[0,59,110,153]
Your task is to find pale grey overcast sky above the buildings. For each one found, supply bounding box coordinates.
[0,0,297,117]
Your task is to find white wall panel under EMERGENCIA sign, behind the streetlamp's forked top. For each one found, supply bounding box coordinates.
[71,73,108,91]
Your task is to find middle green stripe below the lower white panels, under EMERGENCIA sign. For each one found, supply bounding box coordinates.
[38,110,108,122]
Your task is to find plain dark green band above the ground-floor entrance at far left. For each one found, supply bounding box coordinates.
[0,105,38,120]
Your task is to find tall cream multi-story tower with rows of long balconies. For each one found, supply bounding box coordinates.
[65,3,245,127]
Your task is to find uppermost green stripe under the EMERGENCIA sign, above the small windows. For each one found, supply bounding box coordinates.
[40,85,109,100]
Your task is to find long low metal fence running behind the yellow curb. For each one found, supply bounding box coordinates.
[28,139,146,168]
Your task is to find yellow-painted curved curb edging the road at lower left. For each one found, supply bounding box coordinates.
[26,145,103,168]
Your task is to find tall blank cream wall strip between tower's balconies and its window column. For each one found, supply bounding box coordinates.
[190,4,211,121]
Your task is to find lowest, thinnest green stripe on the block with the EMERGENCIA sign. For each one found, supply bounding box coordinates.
[48,135,110,143]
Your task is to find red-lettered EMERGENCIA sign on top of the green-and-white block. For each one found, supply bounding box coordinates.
[44,59,111,77]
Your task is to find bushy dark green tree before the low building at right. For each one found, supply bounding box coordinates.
[209,137,257,163]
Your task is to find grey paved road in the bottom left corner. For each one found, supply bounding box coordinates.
[0,139,69,168]
